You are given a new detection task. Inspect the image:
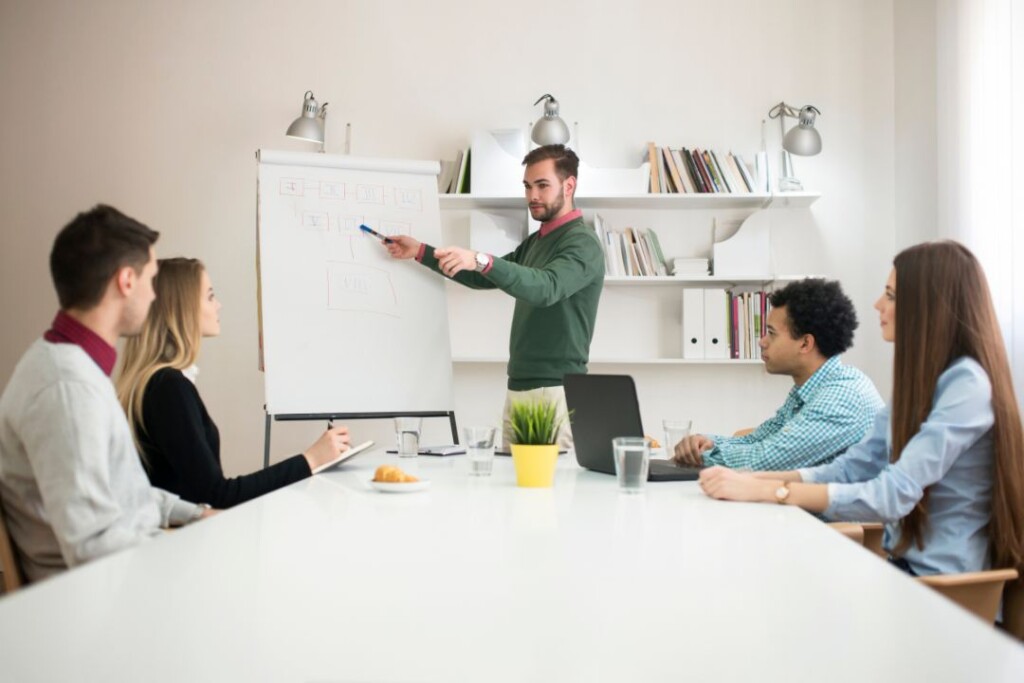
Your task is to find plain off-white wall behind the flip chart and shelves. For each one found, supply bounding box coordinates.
[0,0,896,473]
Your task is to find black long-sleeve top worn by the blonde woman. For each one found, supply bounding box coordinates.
[138,368,310,509]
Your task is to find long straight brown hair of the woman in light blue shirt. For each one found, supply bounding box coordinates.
[891,241,1024,568]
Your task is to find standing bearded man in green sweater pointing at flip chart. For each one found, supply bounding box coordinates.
[387,144,604,449]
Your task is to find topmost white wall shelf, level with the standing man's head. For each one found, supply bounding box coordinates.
[438,193,821,211]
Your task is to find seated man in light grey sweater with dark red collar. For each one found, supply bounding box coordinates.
[0,206,210,581]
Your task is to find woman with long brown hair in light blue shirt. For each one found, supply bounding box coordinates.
[700,242,1024,575]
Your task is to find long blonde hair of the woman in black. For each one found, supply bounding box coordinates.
[117,258,205,454]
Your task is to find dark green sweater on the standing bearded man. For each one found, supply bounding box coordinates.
[422,218,604,391]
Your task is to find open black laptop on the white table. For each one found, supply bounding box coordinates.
[564,375,702,481]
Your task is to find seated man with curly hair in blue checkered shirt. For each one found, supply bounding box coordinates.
[670,280,884,471]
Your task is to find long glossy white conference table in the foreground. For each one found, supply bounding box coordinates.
[0,451,1024,683]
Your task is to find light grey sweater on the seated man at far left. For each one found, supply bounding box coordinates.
[0,339,198,581]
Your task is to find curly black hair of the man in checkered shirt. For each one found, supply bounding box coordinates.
[769,278,857,358]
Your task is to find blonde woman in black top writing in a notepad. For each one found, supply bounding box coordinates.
[117,258,348,508]
